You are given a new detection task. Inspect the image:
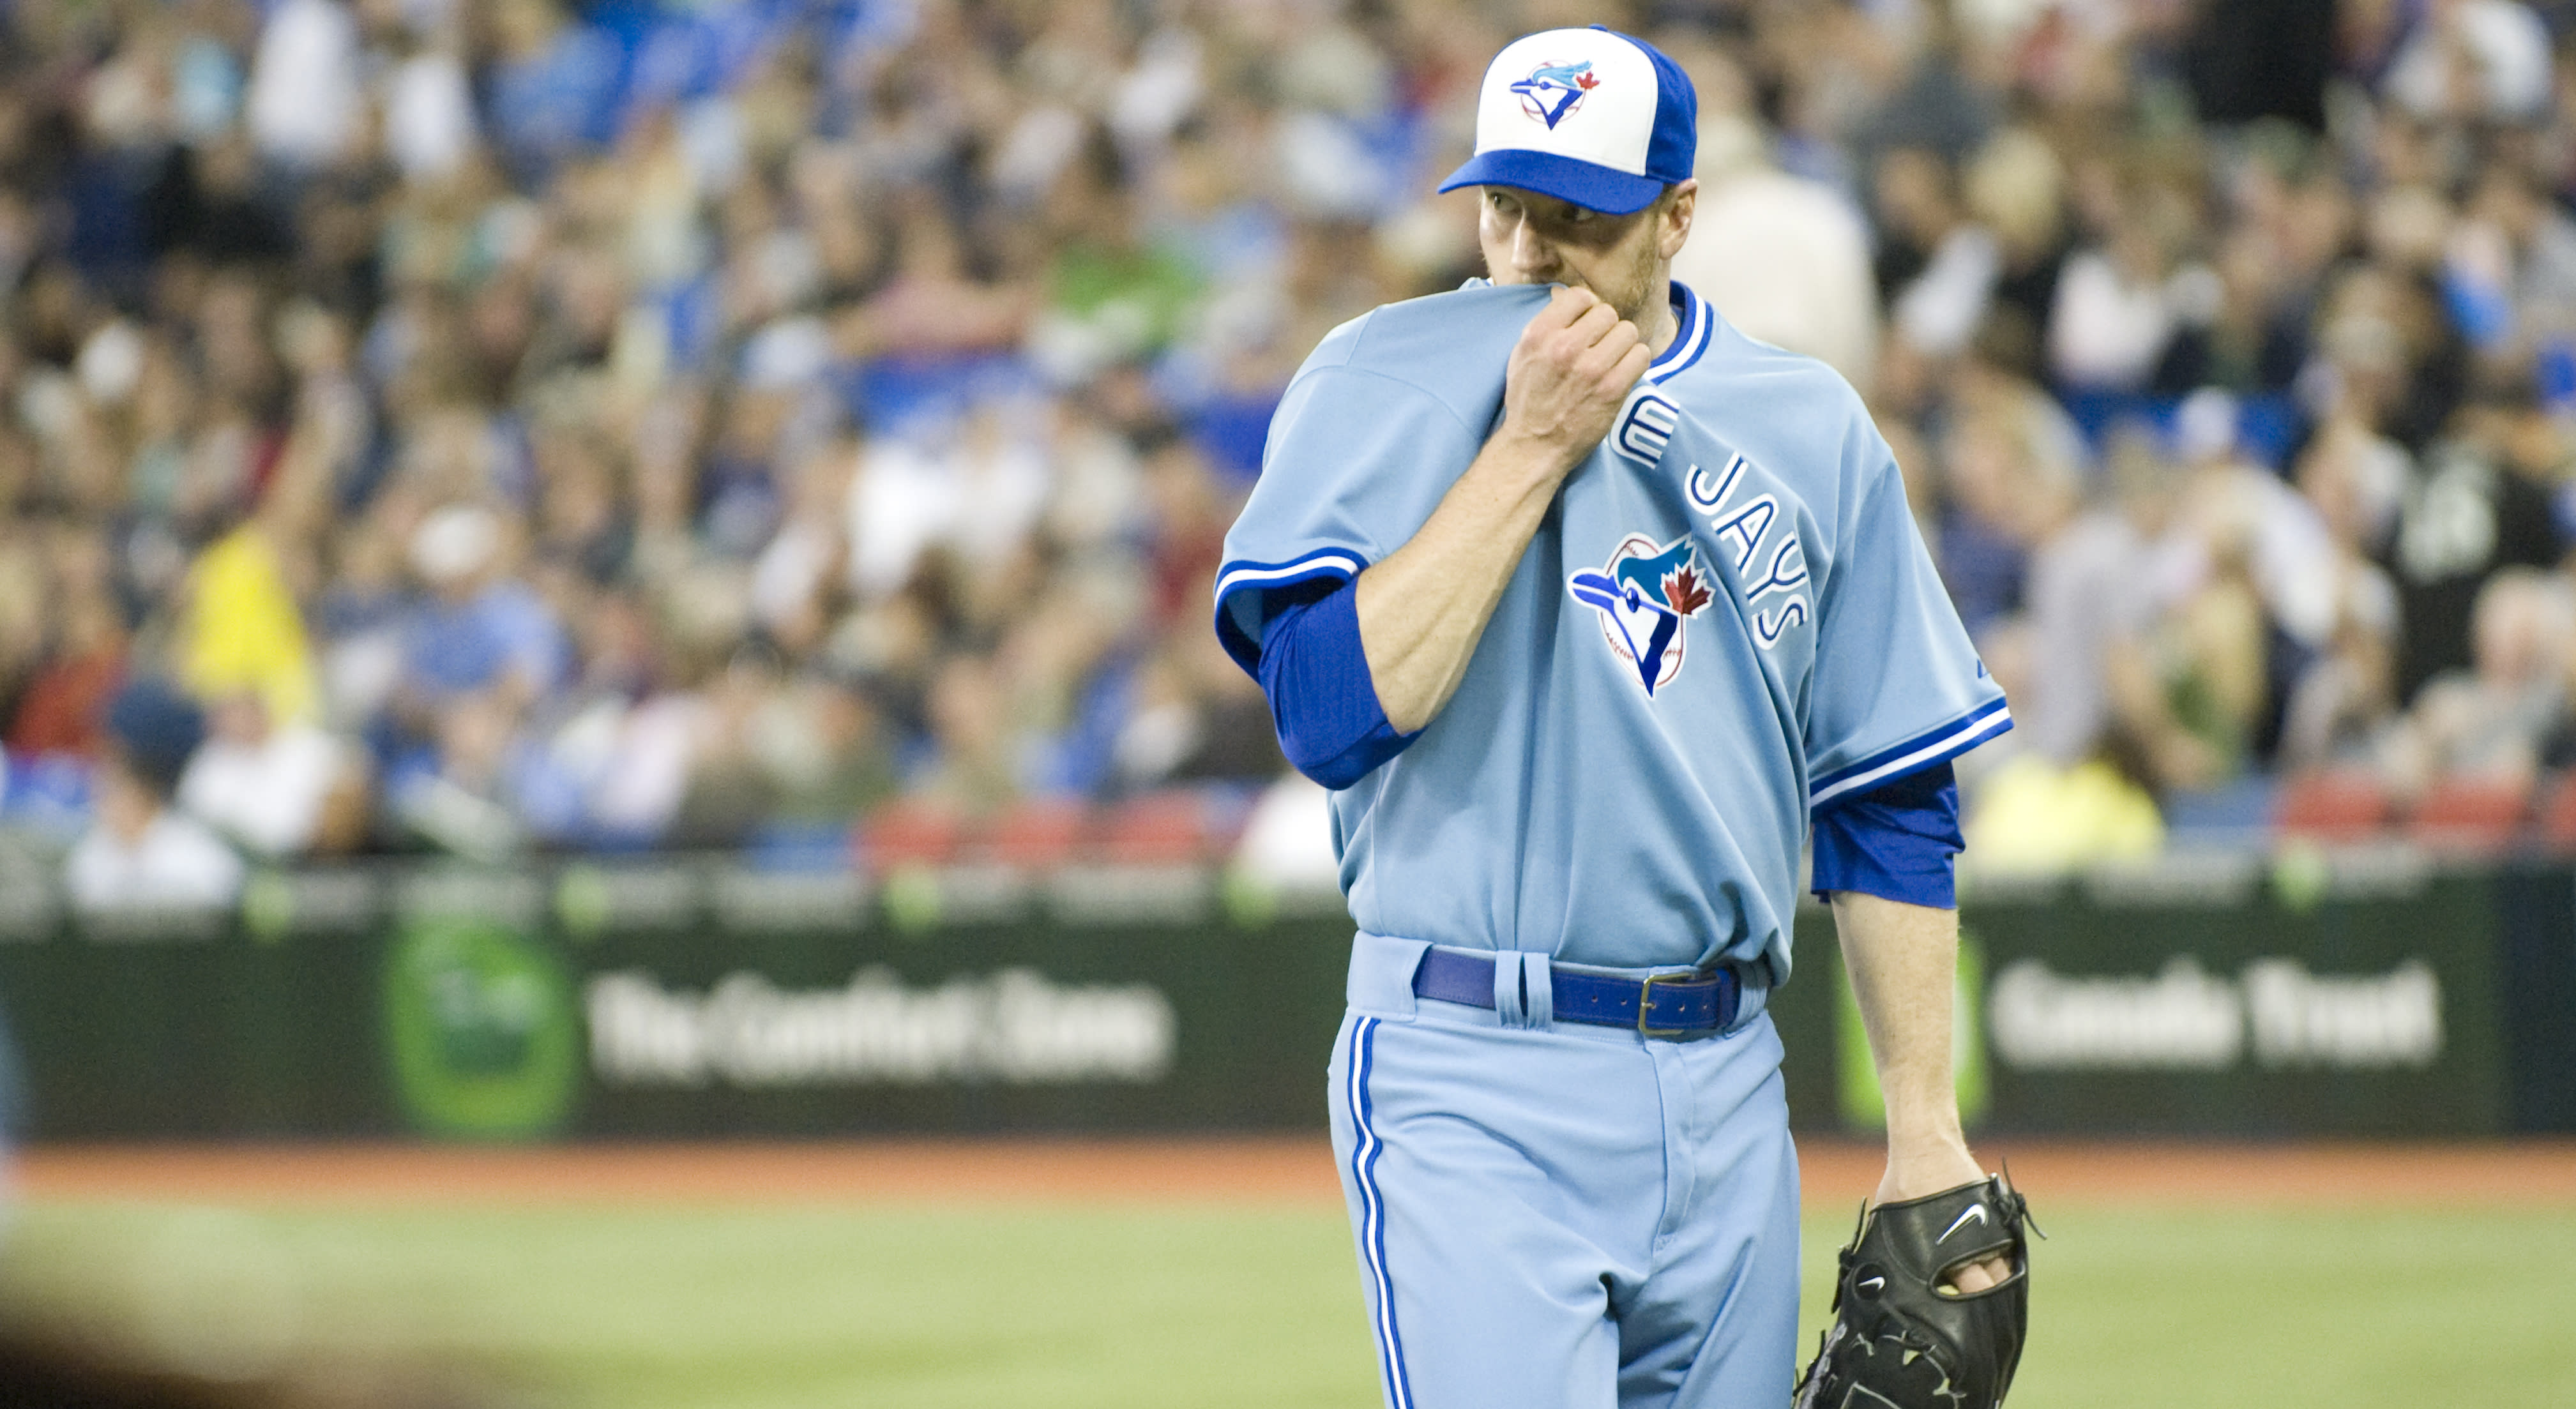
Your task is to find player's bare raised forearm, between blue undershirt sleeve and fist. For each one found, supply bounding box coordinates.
[1355,435,1566,734]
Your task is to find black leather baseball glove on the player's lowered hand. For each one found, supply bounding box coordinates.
[1796,1175,2035,1409]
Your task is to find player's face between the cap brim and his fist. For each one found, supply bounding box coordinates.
[1476,180,1700,335]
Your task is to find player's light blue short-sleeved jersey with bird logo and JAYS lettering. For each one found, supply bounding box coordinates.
[1216,283,2010,979]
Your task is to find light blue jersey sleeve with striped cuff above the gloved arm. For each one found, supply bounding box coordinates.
[1806,407,2012,809]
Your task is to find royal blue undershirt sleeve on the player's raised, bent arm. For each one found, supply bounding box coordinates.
[1260,582,1422,788]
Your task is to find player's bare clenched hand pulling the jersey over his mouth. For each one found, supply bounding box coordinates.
[1497,289,1654,476]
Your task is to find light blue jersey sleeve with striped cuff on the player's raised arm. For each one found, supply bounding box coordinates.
[1216,366,1487,675]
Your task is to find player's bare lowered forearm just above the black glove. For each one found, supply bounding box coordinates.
[1834,891,1966,1164]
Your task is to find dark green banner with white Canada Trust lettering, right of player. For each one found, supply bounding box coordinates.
[1775,855,2509,1136]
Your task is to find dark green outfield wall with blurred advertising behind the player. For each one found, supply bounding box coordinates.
[0,850,2576,1138]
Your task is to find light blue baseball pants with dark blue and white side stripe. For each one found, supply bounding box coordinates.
[1332,935,1798,1409]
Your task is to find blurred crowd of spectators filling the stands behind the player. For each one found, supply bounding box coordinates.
[0,0,2576,896]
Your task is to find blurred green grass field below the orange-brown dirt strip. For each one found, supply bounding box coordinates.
[0,1198,2576,1409]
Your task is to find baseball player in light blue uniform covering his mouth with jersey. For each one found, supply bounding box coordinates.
[1216,28,2022,1409]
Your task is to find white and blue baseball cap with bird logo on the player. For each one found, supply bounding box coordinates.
[1440,26,1700,216]
